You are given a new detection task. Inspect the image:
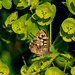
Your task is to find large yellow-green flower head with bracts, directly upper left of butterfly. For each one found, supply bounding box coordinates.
[12,13,35,40]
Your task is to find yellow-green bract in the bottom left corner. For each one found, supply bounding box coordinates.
[0,60,9,75]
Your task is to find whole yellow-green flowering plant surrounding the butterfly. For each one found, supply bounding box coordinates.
[0,0,75,75]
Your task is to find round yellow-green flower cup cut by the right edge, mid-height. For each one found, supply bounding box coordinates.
[61,18,75,34]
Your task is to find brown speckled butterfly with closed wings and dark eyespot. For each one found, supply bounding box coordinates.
[29,30,51,56]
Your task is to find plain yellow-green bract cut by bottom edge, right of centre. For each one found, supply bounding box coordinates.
[45,67,65,75]
